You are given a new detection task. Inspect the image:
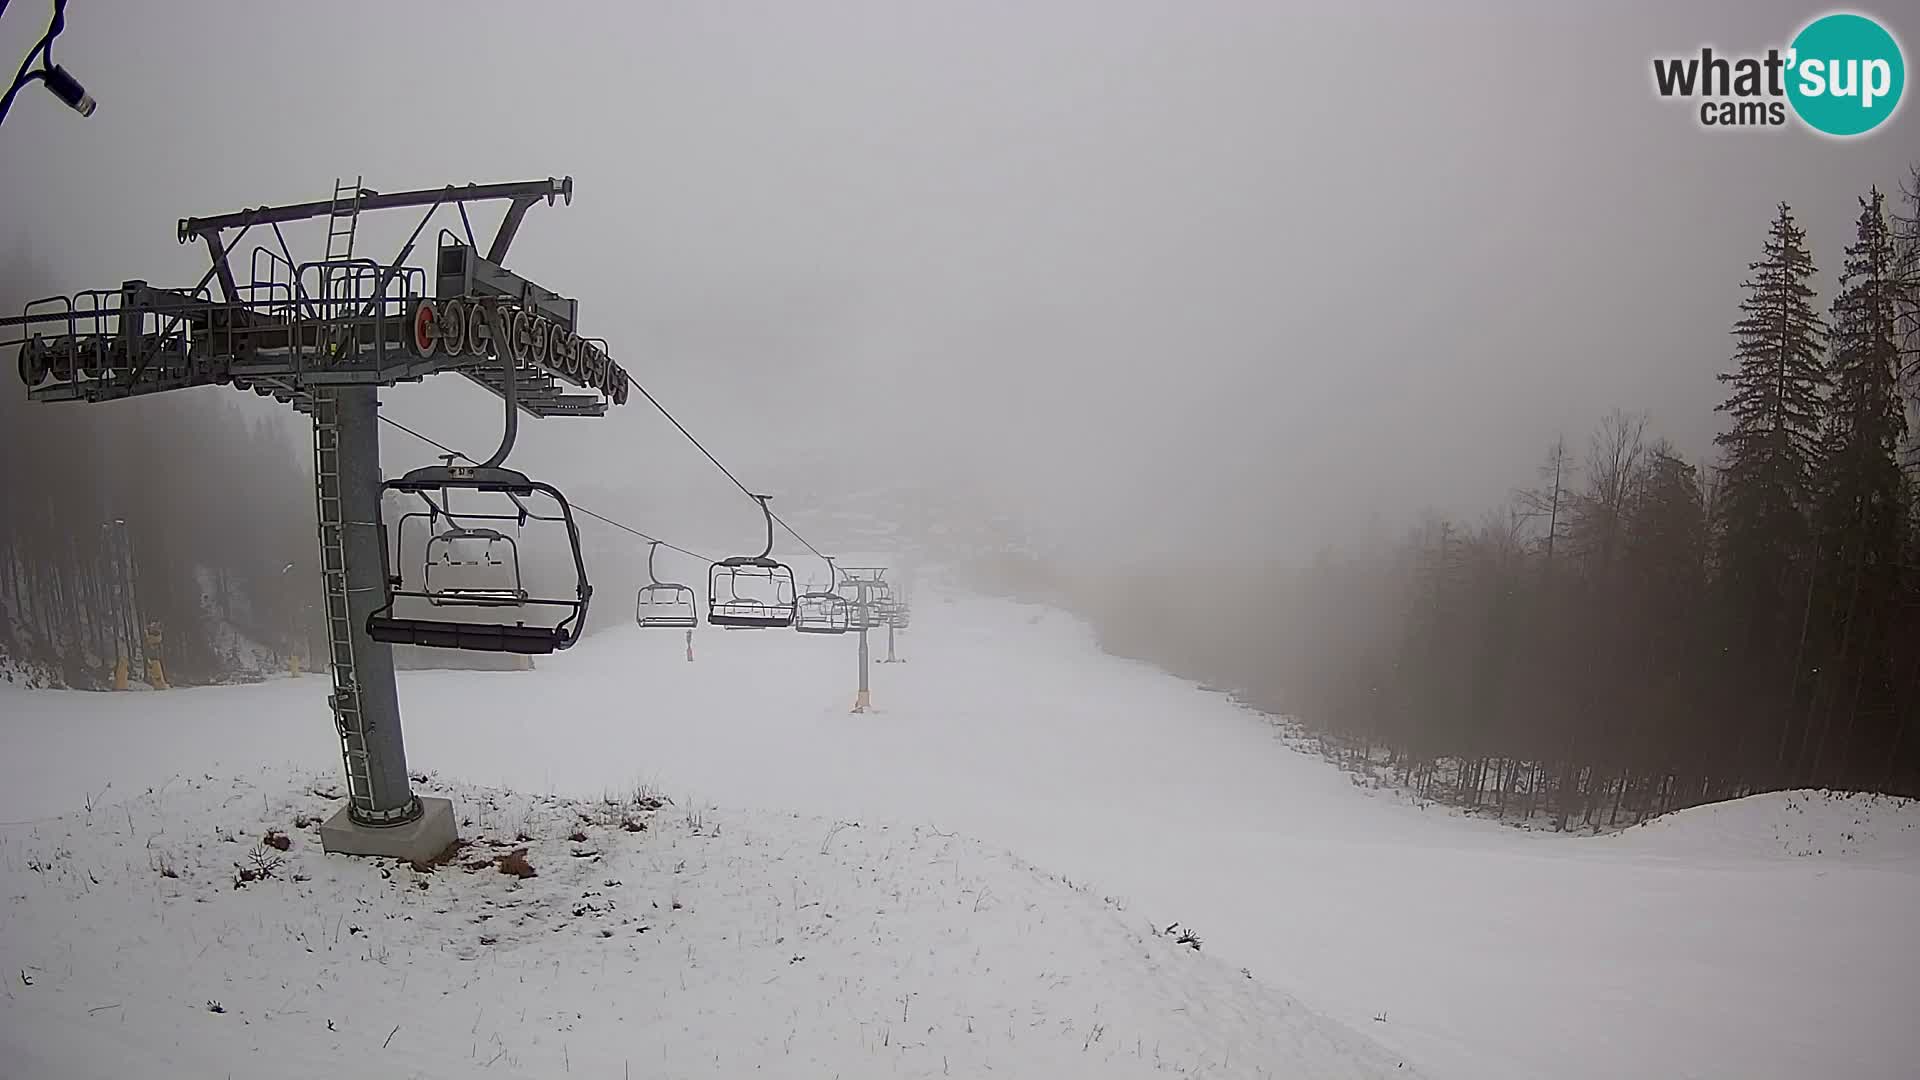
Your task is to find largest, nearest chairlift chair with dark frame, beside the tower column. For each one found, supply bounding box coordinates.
[367,459,593,653]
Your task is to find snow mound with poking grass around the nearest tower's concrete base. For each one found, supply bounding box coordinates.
[0,773,1411,1080]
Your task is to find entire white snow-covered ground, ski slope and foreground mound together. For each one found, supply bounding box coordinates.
[0,584,1920,1080]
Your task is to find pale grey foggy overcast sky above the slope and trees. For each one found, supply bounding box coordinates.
[0,0,1920,557]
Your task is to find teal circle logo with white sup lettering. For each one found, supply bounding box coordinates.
[1788,13,1907,136]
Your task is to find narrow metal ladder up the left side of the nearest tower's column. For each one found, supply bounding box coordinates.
[313,386,372,811]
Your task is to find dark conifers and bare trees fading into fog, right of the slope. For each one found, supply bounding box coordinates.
[1091,169,1920,828]
